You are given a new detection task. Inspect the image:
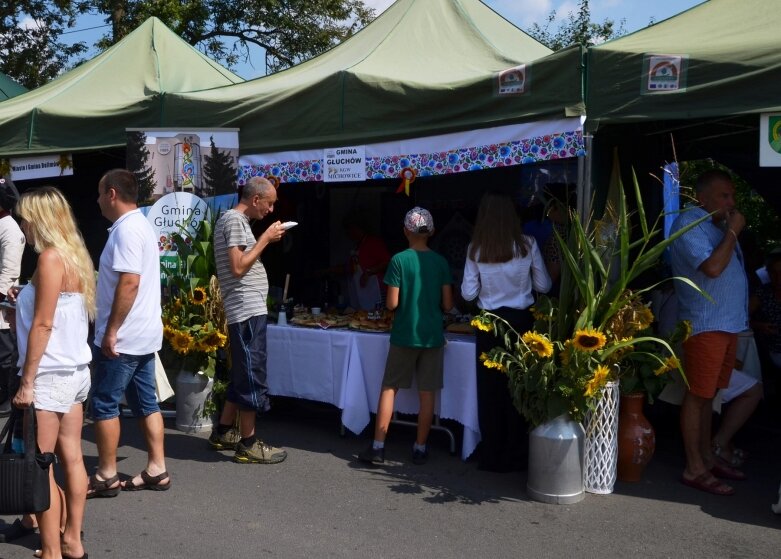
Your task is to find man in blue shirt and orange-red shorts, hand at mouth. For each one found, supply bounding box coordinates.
[671,169,748,495]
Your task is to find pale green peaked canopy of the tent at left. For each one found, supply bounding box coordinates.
[0,18,244,157]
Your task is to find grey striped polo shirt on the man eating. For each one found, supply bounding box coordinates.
[214,210,268,324]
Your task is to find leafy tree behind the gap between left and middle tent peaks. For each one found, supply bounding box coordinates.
[90,0,374,72]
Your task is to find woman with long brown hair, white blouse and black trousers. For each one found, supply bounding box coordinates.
[461,192,551,472]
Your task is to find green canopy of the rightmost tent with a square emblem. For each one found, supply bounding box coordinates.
[586,0,781,207]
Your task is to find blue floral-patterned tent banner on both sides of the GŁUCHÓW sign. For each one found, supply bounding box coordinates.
[238,117,586,185]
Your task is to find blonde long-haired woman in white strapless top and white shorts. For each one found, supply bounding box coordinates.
[9,187,95,559]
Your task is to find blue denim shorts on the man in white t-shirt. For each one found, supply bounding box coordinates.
[91,346,160,421]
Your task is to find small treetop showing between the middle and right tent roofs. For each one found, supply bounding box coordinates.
[527,0,626,50]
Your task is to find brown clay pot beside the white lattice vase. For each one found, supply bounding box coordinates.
[617,392,656,481]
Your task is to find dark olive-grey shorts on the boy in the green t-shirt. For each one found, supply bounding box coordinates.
[382,345,445,392]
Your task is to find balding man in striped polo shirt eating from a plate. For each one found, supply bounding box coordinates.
[209,177,287,464]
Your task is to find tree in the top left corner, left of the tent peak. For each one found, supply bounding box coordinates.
[0,0,87,89]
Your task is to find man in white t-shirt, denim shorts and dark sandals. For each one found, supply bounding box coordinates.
[87,169,171,498]
